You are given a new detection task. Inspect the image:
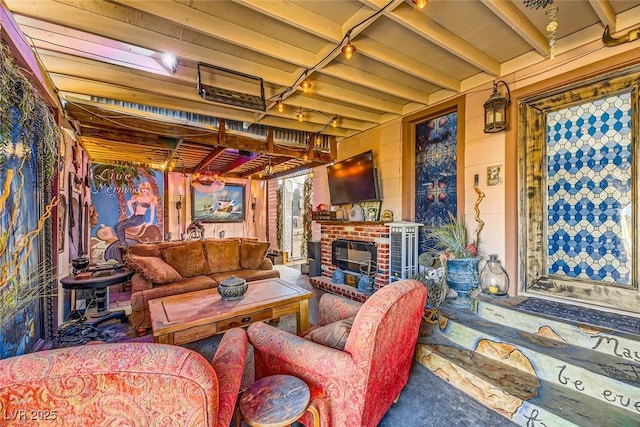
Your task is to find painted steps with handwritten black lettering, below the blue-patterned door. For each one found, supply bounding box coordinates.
[416,300,640,426]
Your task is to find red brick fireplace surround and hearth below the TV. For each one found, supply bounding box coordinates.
[309,221,389,302]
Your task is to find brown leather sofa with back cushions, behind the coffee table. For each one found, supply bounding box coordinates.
[124,239,280,333]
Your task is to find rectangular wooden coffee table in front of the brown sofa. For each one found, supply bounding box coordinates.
[149,279,313,345]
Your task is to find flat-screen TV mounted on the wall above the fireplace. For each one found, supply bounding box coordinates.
[327,151,381,205]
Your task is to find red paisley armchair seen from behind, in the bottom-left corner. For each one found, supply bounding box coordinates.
[0,328,248,427]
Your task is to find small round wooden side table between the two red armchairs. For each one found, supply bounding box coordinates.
[240,375,320,427]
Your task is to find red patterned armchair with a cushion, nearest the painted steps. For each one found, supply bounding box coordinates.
[248,280,427,427]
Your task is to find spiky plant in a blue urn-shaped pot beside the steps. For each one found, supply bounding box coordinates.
[426,214,480,308]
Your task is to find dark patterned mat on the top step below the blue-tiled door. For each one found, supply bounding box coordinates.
[516,298,640,335]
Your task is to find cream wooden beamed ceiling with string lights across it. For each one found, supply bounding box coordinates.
[4,0,640,175]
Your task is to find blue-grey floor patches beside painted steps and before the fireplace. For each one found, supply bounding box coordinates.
[277,266,516,427]
